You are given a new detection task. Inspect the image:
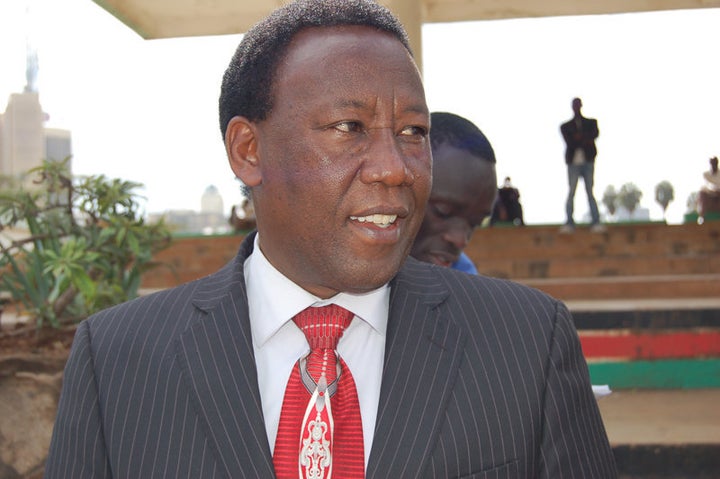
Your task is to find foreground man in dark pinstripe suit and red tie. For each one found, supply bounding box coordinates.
[46,0,614,479]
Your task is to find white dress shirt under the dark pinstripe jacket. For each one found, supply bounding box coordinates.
[245,235,390,467]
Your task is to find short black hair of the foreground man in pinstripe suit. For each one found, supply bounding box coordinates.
[220,0,412,138]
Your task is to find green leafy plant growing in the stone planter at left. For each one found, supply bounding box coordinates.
[0,158,170,328]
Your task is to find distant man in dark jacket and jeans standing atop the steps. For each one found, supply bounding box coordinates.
[560,98,605,233]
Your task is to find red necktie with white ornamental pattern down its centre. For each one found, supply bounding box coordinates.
[273,304,365,479]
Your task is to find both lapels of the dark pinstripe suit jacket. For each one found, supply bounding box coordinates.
[176,242,465,479]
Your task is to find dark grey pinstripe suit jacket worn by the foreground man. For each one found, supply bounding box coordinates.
[46,232,615,479]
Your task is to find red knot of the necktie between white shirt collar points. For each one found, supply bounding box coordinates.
[293,304,354,350]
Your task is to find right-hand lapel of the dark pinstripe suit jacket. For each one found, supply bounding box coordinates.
[367,258,465,478]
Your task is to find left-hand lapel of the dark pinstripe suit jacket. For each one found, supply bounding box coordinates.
[177,235,274,479]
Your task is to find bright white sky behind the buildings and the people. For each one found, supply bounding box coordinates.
[0,0,720,224]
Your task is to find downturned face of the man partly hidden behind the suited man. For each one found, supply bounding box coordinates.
[411,144,497,266]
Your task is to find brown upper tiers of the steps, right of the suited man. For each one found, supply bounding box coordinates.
[466,222,720,301]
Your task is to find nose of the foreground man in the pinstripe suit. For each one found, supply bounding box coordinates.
[360,128,415,186]
